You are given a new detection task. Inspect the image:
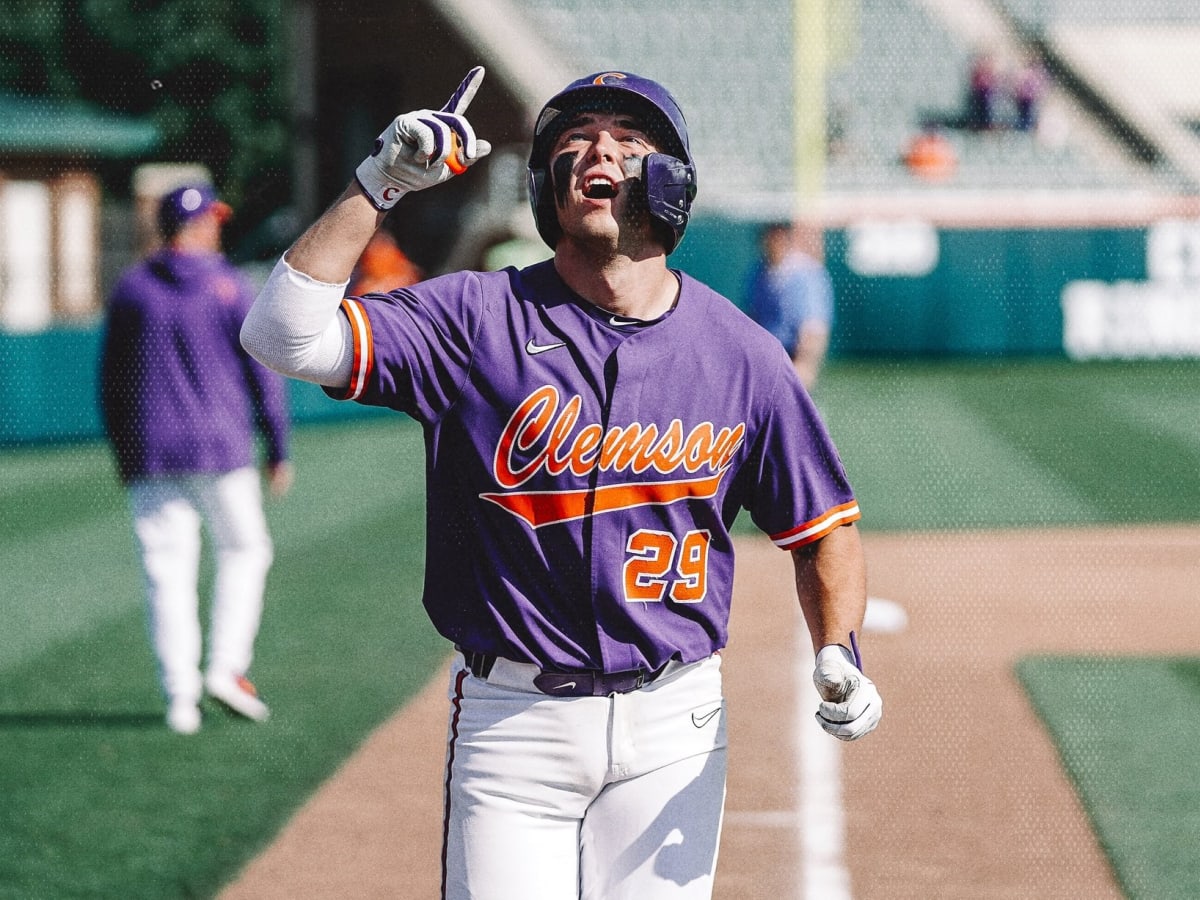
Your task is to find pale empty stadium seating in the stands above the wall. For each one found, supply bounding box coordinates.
[522,0,1200,206]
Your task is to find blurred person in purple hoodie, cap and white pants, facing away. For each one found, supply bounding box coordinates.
[101,184,292,734]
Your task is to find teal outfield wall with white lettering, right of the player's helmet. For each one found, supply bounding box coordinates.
[671,215,1200,359]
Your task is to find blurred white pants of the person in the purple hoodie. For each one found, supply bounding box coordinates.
[130,467,274,703]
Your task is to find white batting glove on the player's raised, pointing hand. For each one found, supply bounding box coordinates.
[354,66,492,210]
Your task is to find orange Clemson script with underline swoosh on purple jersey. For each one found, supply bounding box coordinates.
[480,385,746,528]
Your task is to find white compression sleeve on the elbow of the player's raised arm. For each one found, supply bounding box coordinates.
[241,257,354,388]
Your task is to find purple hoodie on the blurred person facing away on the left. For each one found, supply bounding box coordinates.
[100,248,288,482]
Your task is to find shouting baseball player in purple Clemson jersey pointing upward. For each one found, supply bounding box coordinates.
[242,68,881,900]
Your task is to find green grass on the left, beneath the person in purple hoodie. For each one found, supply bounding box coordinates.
[0,416,445,899]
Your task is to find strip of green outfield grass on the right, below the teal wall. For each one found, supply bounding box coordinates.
[817,360,1200,530]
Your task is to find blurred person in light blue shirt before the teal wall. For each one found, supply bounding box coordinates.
[746,222,833,390]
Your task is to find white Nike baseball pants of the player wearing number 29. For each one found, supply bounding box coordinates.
[444,654,726,900]
